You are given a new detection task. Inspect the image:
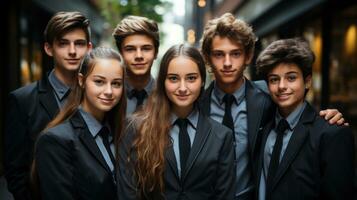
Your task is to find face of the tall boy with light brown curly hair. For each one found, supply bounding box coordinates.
[210,36,251,93]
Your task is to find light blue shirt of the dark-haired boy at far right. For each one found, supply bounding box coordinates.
[259,102,306,200]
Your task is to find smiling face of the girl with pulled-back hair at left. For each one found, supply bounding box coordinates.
[79,59,124,121]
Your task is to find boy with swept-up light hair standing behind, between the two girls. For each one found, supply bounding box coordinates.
[113,16,160,115]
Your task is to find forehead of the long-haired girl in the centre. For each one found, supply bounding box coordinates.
[167,56,199,74]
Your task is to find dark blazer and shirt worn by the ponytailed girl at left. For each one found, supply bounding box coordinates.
[35,109,117,200]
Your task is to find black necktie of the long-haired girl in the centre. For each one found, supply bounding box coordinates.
[176,118,191,176]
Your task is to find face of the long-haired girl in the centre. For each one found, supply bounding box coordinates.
[165,56,203,117]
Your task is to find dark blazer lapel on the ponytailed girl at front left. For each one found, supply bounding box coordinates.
[70,111,112,173]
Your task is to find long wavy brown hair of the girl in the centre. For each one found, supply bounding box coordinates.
[129,44,206,199]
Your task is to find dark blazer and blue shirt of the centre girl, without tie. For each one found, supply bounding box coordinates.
[117,108,235,200]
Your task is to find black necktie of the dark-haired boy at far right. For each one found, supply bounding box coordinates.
[267,119,289,190]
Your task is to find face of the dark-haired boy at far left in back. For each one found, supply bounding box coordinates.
[44,28,92,72]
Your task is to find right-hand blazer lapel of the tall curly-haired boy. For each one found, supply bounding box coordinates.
[245,80,267,158]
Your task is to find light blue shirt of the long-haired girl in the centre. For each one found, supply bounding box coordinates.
[170,109,199,177]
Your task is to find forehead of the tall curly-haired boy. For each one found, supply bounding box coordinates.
[211,35,243,51]
